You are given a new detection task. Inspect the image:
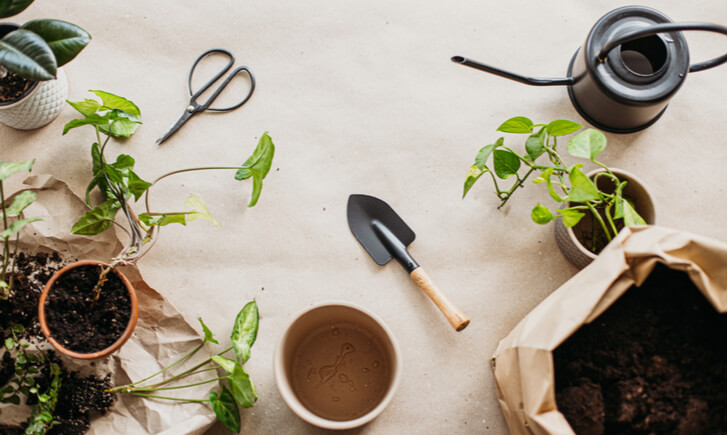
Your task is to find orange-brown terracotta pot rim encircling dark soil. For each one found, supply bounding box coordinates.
[38,260,139,359]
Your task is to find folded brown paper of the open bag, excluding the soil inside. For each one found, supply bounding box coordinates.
[492,227,726,434]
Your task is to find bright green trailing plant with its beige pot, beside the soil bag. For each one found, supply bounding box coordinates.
[463,116,655,268]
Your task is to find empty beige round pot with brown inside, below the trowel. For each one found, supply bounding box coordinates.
[273,302,402,430]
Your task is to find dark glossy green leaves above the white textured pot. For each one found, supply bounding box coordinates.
[0,0,91,80]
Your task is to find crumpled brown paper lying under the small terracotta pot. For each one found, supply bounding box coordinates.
[0,175,215,435]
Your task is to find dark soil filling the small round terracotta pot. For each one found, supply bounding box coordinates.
[45,265,131,353]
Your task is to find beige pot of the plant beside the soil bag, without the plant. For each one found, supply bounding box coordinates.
[554,168,655,269]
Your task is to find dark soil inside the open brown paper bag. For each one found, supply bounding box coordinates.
[553,265,726,434]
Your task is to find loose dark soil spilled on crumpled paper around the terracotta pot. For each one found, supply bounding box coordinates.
[0,253,114,435]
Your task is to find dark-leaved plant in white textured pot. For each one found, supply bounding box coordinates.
[0,0,91,130]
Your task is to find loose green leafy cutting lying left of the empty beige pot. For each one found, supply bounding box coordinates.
[106,301,258,433]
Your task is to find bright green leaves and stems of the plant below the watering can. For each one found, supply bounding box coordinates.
[463,116,645,248]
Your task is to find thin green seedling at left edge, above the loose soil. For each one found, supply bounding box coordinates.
[0,160,43,299]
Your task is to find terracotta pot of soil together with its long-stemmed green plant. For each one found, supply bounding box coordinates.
[39,91,275,359]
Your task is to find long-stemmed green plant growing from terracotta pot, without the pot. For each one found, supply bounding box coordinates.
[63,91,275,282]
